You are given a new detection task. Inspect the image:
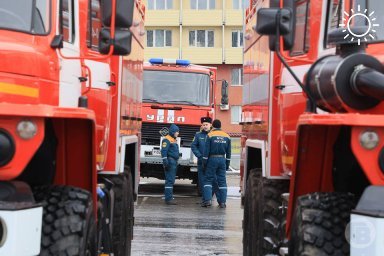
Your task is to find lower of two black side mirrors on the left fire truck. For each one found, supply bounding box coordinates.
[99,28,132,56]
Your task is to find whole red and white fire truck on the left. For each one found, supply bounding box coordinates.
[0,0,145,256]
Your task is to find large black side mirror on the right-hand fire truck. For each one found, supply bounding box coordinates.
[255,8,294,51]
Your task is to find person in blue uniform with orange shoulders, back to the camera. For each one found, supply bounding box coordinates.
[201,119,231,208]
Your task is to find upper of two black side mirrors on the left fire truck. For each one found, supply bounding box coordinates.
[101,0,135,29]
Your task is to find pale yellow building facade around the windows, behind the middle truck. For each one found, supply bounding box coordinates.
[145,0,243,64]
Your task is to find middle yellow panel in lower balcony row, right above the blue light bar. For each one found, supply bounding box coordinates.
[182,47,223,64]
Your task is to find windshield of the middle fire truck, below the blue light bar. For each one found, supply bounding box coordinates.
[143,70,210,106]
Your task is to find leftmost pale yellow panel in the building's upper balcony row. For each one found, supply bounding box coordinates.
[145,10,180,27]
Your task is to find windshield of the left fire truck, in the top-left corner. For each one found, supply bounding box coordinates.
[0,0,50,35]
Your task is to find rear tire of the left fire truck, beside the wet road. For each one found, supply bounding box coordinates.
[110,169,134,256]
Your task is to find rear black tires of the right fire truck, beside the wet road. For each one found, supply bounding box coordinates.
[243,170,289,256]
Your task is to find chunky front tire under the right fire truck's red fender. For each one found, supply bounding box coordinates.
[289,192,355,256]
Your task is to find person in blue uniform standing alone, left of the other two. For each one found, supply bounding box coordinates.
[161,124,179,205]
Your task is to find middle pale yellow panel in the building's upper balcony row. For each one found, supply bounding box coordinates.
[182,10,223,27]
